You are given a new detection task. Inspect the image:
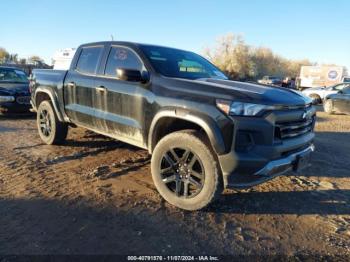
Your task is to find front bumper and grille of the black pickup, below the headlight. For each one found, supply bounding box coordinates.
[218,104,315,188]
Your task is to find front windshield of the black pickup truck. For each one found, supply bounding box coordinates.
[141,46,227,79]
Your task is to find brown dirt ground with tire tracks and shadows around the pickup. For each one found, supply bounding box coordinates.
[0,109,350,260]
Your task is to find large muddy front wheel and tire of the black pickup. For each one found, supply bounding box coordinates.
[151,131,223,210]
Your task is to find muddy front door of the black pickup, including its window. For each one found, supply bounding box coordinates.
[96,45,150,147]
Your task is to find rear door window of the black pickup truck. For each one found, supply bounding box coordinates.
[76,46,103,74]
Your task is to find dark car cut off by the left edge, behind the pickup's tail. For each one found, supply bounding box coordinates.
[0,66,31,114]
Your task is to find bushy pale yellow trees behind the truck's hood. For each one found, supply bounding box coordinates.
[204,33,316,80]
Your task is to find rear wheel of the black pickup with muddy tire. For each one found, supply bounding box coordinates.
[36,101,68,145]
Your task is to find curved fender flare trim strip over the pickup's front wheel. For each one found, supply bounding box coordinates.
[148,109,226,155]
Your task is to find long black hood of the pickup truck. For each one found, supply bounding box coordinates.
[159,78,312,106]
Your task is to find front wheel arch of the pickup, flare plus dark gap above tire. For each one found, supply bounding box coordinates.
[148,109,225,155]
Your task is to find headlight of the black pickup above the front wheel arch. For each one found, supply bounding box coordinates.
[216,100,275,116]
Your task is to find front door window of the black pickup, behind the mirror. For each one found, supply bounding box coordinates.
[105,47,142,76]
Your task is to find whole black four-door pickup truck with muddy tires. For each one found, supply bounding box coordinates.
[31,42,315,210]
